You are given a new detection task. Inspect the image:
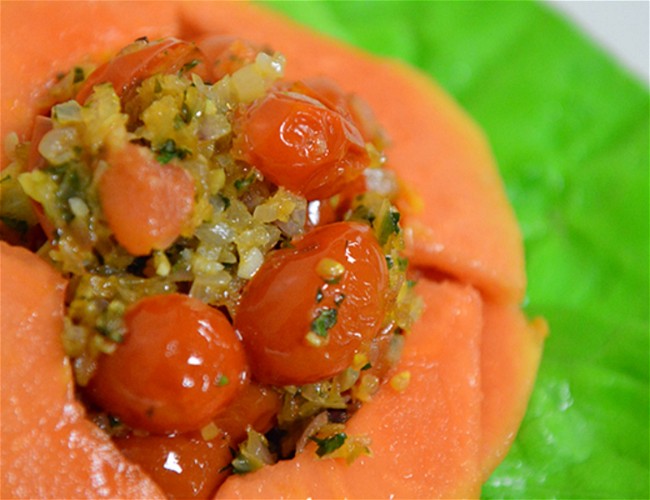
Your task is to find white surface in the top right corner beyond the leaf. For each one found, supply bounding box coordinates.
[547,0,650,83]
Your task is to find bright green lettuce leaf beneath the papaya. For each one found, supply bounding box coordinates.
[264,2,650,498]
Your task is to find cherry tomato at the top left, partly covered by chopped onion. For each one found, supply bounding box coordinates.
[77,38,210,104]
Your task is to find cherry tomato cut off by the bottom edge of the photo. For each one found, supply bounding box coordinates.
[114,433,232,498]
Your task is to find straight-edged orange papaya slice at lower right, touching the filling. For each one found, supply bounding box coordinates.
[216,280,483,498]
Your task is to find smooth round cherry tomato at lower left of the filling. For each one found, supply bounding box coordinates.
[89,294,246,433]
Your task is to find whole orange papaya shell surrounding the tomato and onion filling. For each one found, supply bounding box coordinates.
[0,2,545,498]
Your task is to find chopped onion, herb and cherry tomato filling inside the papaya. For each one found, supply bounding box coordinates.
[0,36,420,497]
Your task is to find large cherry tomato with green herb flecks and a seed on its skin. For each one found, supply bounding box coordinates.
[235,222,388,385]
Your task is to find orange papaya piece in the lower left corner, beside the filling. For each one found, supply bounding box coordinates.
[0,242,162,498]
